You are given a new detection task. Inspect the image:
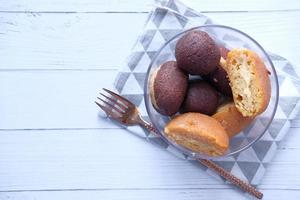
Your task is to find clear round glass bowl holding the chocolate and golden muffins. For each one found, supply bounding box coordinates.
[144,25,279,159]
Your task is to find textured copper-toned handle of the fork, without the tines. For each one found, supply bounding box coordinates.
[139,119,263,199]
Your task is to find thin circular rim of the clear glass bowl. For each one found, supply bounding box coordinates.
[144,24,279,159]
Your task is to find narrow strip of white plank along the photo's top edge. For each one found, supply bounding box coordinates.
[0,0,300,12]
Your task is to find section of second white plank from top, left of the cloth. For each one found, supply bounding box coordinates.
[0,13,146,70]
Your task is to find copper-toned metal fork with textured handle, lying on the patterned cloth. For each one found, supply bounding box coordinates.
[95,88,263,199]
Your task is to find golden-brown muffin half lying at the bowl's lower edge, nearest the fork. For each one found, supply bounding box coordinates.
[164,113,229,156]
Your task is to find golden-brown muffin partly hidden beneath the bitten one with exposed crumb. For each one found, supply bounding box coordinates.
[212,102,253,138]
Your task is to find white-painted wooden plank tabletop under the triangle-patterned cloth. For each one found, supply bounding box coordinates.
[0,0,300,200]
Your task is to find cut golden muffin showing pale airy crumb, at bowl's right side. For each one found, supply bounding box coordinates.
[225,49,271,117]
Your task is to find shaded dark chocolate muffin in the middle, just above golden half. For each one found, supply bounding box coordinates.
[181,81,219,115]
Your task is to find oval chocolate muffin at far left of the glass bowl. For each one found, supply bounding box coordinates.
[150,61,188,116]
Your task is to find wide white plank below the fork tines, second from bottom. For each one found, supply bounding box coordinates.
[0,129,300,192]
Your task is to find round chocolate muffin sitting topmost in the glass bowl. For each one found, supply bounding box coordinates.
[175,31,221,75]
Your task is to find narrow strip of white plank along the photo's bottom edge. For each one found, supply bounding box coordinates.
[0,189,300,200]
